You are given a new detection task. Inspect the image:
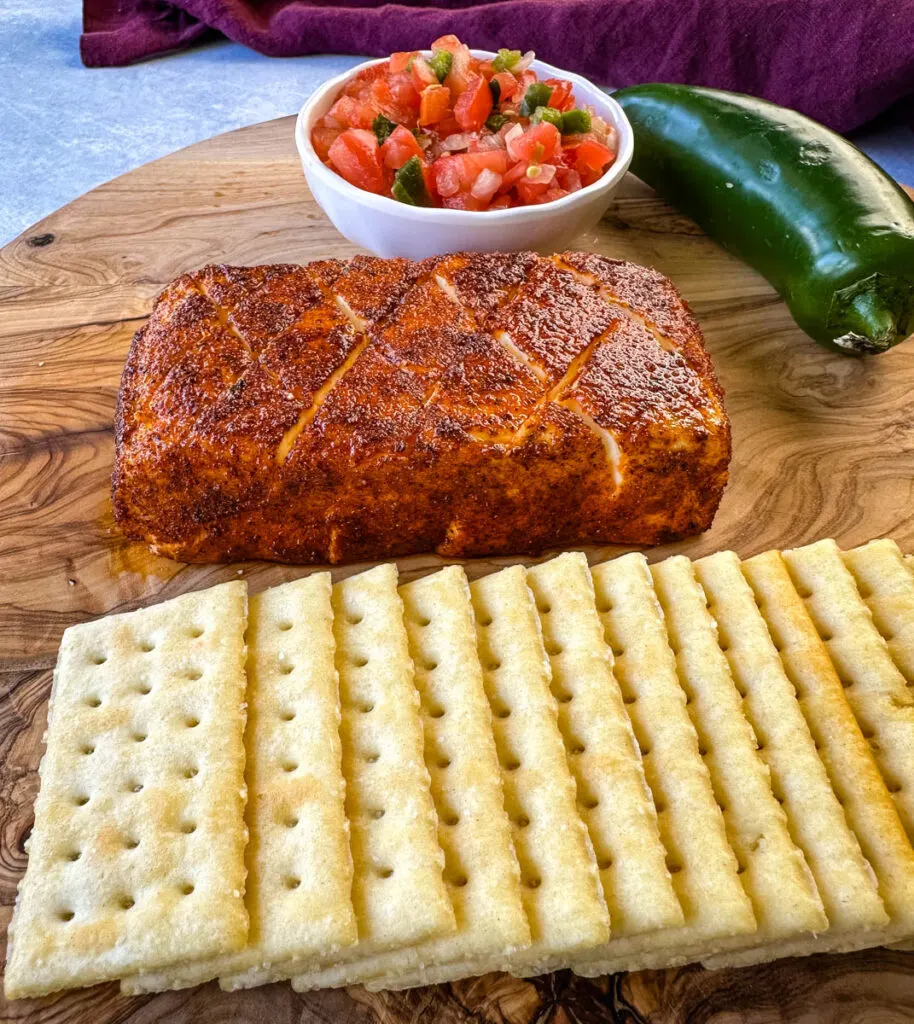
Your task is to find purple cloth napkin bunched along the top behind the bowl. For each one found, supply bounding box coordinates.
[80,0,914,131]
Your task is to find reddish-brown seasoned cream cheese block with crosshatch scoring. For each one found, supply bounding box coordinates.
[113,252,731,563]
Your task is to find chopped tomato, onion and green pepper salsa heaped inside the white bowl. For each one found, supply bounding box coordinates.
[311,36,616,211]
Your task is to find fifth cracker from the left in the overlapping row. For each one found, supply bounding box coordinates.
[470,565,610,969]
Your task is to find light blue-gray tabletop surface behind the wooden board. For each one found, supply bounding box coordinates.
[0,0,914,245]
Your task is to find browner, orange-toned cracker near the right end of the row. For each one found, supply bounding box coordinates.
[742,551,914,935]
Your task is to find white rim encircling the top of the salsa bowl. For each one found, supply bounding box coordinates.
[295,49,635,224]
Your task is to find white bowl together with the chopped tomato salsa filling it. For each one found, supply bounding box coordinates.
[296,37,633,259]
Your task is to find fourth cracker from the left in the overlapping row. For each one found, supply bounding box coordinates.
[293,565,530,991]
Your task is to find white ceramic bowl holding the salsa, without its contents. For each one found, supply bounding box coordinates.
[295,50,633,259]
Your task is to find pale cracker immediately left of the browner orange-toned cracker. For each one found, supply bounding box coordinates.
[694,551,888,966]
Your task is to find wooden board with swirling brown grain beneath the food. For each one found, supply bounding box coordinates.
[0,119,914,1024]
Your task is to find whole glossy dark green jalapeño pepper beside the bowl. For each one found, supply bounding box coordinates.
[614,84,914,355]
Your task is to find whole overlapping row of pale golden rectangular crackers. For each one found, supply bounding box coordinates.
[5,541,914,997]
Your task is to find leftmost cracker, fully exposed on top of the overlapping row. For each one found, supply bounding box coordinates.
[5,582,248,998]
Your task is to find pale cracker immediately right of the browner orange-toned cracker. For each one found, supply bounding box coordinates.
[783,541,914,839]
